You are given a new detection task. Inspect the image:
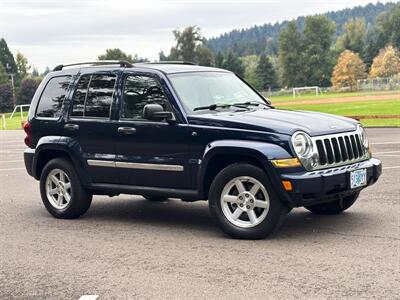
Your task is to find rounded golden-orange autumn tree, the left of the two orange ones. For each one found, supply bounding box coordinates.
[332,50,367,91]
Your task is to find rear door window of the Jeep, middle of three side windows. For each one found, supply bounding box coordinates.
[71,74,116,118]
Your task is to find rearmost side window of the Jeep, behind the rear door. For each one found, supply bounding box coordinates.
[36,76,71,118]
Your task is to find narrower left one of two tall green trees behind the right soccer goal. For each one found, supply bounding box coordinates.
[279,21,304,87]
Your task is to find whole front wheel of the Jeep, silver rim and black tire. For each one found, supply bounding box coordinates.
[209,163,289,239]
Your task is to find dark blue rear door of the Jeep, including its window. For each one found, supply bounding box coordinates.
[64,72,118,183]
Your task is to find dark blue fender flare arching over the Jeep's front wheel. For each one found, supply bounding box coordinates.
[197,140,293,197]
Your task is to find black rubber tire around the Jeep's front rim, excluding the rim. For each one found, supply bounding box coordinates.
[209,163,288,239]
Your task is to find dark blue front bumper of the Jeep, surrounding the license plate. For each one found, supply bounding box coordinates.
[280,158,382,207]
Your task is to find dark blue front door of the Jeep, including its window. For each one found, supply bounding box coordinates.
[116,74,190,189]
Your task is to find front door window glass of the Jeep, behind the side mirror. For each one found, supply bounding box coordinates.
[121,75,170,120]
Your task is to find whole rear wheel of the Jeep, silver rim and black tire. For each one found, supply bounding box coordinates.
[40,158,92,219]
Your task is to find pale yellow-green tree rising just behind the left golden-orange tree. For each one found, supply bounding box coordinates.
[336,18,367,56]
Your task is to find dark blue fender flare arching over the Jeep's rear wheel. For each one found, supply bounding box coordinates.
[32,136,90,186]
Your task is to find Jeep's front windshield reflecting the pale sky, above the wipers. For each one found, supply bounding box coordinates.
[169,72,266,112]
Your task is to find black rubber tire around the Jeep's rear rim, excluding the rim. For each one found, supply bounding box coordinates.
[40,158,92,219]
